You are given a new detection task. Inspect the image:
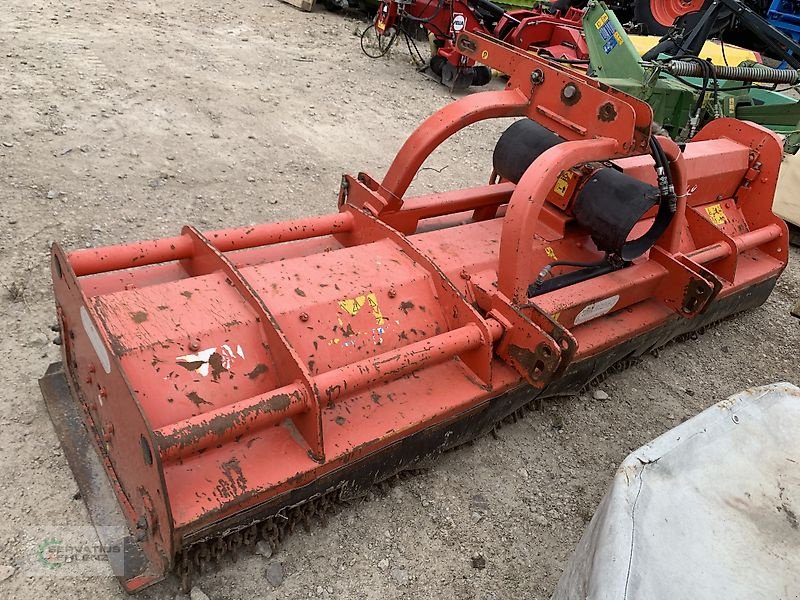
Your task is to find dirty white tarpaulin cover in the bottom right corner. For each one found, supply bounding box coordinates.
[553,383,800,600]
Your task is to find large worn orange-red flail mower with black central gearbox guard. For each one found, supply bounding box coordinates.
[41,34,788,591]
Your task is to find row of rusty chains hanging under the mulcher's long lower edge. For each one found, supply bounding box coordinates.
[174,319,727,592]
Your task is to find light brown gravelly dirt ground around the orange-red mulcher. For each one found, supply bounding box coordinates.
[0,0,800,600]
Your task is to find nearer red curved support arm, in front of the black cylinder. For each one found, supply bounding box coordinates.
[497,138,617,303]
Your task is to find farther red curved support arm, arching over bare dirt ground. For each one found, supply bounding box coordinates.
[380,89,530,211]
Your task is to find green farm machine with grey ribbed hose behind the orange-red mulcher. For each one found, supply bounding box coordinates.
[583,2,800,153]
